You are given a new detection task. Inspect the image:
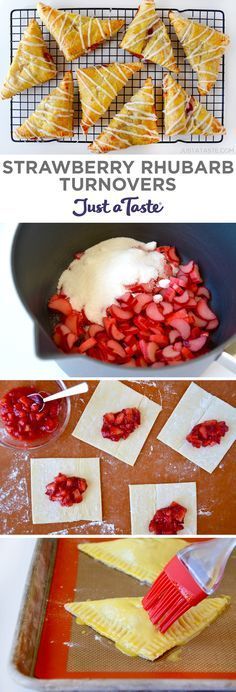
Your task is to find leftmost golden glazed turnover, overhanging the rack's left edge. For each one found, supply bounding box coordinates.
[0,19,57,99]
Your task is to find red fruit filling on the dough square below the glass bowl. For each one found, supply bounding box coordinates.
[45,473,88,507]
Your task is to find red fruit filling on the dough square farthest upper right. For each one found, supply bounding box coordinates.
[186,420,229,449]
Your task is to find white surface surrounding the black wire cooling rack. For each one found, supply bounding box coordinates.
[0,0,236,155]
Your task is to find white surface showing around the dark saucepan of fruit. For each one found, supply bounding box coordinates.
[0,223,236,378]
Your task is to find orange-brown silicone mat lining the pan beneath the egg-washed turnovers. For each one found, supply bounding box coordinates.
[34,538,236,679]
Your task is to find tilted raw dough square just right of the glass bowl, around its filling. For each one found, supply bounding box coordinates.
[72,380,161,466]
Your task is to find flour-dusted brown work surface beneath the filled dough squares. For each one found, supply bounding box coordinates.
[0,380,236,535]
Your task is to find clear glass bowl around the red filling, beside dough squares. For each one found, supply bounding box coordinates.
[0,380,71,450]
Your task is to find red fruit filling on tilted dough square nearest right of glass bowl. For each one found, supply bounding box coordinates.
[101,408,141,442]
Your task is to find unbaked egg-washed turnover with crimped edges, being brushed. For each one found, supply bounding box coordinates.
[65,596,230,661]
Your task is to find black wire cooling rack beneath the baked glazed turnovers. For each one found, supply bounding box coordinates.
[11,7,225,144]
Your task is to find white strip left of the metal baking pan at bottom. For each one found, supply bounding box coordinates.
[0,536,36,692]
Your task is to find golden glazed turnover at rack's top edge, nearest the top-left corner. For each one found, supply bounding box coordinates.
[37,2,124,62]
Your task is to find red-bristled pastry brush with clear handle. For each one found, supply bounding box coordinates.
[142,537,236,633]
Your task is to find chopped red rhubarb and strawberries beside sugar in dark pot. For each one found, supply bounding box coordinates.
[48,245,219,367]
